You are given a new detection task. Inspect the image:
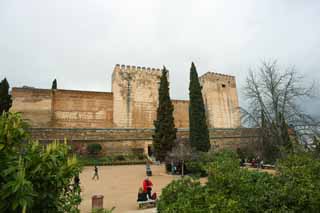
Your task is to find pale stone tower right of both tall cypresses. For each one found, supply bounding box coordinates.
[199,72,240,128]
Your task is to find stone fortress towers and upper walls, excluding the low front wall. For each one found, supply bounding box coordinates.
[12,65,240,128]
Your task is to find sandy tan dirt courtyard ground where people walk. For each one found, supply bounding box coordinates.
[80,165,179,213]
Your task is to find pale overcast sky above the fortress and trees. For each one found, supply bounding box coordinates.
[0,0,320,115]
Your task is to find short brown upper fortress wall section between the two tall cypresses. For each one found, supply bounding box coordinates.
[172,100,189,128]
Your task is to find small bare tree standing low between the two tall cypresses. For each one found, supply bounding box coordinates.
[167,137,192,177]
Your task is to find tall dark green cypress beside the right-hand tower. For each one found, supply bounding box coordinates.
[189,62,210,152]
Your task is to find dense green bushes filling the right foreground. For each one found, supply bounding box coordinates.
[157,151,320,212]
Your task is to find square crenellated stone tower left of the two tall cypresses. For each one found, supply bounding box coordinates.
[112,65,161,128]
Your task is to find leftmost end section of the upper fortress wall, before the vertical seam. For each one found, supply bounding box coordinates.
[10,88,52,127]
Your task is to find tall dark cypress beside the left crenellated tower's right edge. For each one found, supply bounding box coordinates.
[152,67,177,161]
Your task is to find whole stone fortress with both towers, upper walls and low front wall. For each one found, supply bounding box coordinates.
[11,64,257,153]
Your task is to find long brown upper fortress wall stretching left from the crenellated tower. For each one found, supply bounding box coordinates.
[11,88,113,128]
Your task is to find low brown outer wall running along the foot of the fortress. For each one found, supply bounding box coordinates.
[30,128,259,154]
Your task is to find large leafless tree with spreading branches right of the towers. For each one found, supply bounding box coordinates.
[241,61,319,156]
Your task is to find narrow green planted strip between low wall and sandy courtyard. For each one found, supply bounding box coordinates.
[78,154,146,166]
